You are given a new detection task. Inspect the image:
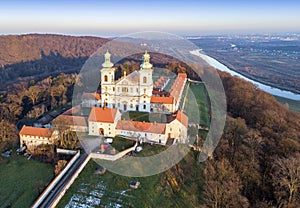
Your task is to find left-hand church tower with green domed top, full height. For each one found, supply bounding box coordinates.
[100,51,115,108]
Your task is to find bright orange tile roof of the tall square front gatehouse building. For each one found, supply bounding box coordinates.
[89,107,118,123]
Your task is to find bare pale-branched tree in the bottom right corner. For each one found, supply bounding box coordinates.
[271,153,300,208]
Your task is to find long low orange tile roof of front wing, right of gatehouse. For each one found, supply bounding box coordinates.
[116,120,166,134]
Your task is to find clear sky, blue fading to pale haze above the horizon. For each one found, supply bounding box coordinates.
[0,0,300,36]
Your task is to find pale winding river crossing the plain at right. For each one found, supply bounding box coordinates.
[190,49,300,101]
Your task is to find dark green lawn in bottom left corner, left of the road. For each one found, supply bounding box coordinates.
[0,152,53,208]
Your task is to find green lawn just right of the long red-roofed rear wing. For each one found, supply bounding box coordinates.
[184,83,210,127]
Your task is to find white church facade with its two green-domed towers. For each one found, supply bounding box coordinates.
[101,52,153,112]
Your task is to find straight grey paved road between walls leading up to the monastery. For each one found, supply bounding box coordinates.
[39,153,88,208]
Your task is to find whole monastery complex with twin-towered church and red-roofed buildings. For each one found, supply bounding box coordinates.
[20,51,188,148]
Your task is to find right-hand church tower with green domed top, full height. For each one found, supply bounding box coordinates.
[139,51,153,112]
